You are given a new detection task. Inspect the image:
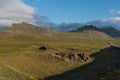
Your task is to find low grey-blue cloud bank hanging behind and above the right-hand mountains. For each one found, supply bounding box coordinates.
[56,10,120,31]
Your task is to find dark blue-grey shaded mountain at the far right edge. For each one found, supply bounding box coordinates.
[101,27,120,38]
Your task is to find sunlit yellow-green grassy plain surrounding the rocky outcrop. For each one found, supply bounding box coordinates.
[0,33,119,79]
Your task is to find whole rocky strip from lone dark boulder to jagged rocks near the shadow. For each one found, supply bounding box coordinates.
[38,46,91,62]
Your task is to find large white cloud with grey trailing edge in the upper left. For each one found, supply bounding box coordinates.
[0,0,48,26]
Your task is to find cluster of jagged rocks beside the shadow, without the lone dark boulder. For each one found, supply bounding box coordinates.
[55,51,91,62]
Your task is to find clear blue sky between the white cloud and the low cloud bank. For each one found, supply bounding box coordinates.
[24,0,120,23]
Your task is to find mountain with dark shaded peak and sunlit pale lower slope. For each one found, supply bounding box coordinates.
[71,25,110,39]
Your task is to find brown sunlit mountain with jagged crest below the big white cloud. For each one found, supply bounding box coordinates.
[8,22,55,34]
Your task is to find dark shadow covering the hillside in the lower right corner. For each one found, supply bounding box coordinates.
[44,46,120,80]
